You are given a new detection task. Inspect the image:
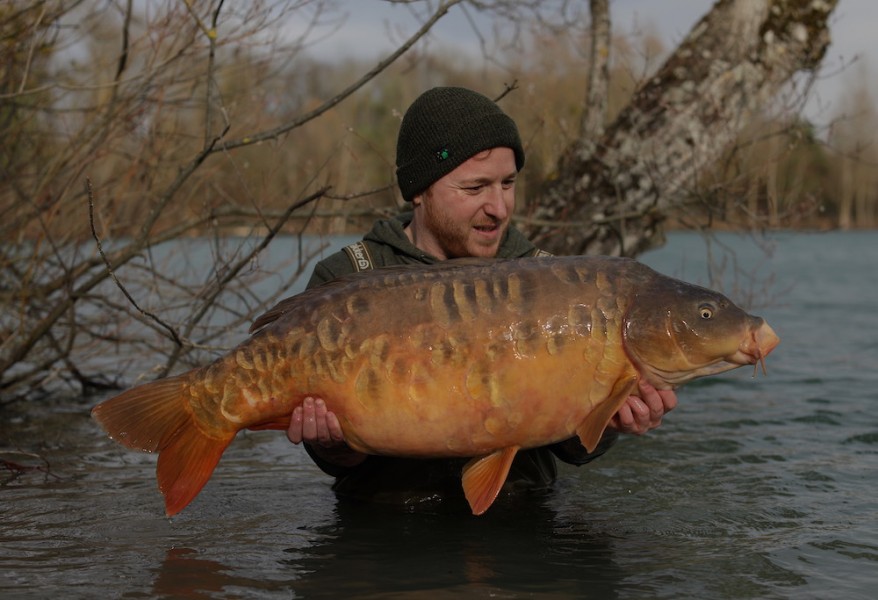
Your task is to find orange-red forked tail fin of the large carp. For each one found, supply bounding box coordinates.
[91,373,235,517]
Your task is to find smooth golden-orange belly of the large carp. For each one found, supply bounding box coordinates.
[334,332,624,457]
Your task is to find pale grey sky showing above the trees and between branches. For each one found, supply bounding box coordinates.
[288,0,878,121]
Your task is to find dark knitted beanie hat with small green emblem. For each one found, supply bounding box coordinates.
[396,87,524,201]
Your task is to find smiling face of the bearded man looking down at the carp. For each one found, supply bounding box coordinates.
[410,148,517,259]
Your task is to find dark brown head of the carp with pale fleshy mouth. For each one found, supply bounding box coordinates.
[624,276,780,389]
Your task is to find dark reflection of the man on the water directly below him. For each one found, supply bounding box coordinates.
[287,495,621,598]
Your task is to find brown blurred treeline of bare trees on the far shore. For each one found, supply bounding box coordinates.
[0,2,878,246]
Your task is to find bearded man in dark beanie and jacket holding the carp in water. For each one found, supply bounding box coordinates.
[287,88,677,505]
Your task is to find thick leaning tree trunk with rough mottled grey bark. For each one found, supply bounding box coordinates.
[525,0,838,256]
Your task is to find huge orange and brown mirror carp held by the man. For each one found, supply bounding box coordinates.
[92,256,779,516]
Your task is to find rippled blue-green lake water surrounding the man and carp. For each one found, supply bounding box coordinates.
[0,232,878,599]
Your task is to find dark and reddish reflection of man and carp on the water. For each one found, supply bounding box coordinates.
[139,498,624,598]
